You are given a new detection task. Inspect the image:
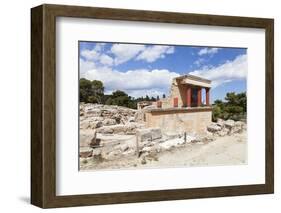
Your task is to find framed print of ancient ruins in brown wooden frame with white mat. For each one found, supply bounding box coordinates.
[31,5,274,208]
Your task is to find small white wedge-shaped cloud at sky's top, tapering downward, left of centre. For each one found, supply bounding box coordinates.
[110,44,145,65]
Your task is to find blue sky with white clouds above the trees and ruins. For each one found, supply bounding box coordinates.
[79,42,247,101]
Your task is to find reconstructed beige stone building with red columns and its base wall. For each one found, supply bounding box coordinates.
[145,75,212,133]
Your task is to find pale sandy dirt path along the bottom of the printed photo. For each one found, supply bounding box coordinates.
[81,132,247,170]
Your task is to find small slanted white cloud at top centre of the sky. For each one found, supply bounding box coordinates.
[136,45,174,62]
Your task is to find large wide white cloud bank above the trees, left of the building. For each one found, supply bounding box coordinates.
[81,67,179,97]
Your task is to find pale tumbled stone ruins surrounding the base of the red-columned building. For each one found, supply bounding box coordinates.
[80,103,246,166]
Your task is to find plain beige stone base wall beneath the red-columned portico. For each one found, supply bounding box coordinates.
[145,107,212,134]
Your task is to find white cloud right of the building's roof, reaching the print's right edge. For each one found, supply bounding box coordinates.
[189,55,248,87]
